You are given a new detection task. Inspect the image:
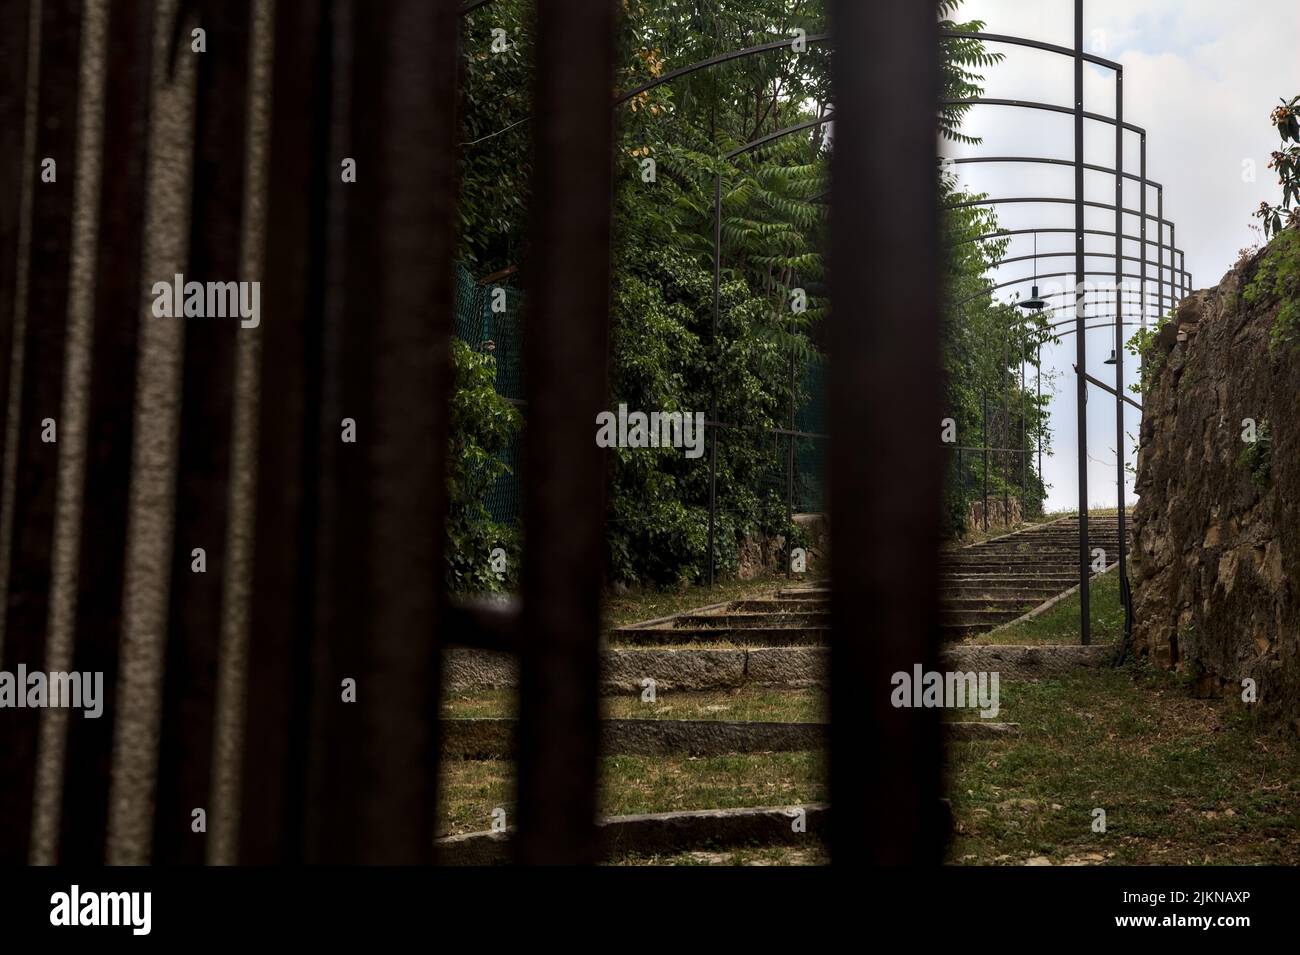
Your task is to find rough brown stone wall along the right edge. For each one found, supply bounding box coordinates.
[1132,246,1300,729]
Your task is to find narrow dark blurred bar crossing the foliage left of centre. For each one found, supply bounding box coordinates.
[516,0,616,863]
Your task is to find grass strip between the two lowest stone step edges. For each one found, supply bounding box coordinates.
[438,752,827,833]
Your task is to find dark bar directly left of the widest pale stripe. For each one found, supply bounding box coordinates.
[59,0,153,865]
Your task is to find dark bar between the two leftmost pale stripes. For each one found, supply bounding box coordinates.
[0,0,82,864]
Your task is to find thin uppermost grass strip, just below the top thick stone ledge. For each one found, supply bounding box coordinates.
[442,689,826,722]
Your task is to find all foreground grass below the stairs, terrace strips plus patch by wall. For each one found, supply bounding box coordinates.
[439,667,1300,865]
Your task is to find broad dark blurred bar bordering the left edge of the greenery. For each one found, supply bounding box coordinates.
[306,0,462,864]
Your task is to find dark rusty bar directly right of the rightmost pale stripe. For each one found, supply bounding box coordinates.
[238,0,335,864]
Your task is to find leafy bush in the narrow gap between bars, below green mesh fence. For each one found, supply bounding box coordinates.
[446,339,523,592]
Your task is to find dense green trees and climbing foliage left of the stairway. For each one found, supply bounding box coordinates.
[452,0,1029,589]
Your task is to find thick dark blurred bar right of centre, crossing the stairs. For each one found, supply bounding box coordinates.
[829,0,944,864]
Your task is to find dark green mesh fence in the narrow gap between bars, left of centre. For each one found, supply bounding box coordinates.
[455,265,524,524]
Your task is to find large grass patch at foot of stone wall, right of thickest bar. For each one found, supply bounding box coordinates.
[949,668,1300,865]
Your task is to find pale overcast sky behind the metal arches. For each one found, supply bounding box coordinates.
[945,0,1300,509]
